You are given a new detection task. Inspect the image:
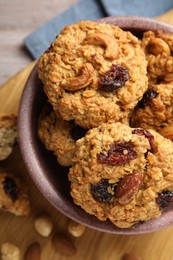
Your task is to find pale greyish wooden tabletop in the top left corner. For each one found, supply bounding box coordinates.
[0,0,78,85]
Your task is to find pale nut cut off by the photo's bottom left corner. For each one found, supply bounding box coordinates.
[1,243,21,260]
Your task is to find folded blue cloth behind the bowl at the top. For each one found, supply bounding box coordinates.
[24,0,173,59]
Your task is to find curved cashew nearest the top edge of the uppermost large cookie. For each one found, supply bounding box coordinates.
[87,32,118,60]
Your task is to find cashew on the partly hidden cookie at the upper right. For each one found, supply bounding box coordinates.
[148,38,171,56]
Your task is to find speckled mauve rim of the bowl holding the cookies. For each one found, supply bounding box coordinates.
[18,16,173,235]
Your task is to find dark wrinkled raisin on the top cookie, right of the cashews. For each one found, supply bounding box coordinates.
[99,64,129,92]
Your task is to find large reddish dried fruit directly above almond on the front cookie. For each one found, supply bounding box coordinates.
[97,142,137,166]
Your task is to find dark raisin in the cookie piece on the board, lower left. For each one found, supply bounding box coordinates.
[2,177,19,201]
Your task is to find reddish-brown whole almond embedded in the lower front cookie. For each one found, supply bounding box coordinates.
[115,173,143,205]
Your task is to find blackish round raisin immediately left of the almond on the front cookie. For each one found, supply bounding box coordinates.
[91,179,114,202]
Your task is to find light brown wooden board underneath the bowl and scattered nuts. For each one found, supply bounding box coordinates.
[0,10,173,260]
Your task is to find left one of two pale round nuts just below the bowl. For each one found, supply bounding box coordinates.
[34,214,53,237]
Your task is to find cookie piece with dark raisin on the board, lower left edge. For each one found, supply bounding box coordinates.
[0,172,30,216]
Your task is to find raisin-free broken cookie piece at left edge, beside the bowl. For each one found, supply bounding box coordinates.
[0,114,17,161]
